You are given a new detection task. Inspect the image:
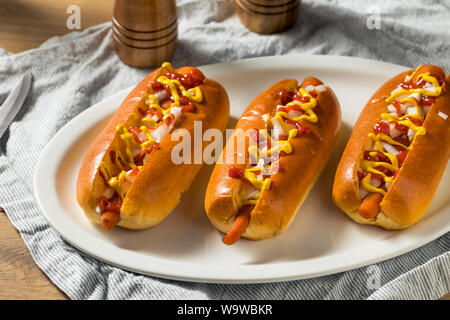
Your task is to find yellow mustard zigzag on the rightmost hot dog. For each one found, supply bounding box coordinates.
[361,65,442,195]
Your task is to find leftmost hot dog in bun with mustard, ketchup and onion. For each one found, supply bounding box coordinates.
[77,63,229,231]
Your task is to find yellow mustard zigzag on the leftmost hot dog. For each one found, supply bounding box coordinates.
[99,62,203,199]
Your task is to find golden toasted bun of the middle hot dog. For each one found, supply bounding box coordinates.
[205,78,341,240]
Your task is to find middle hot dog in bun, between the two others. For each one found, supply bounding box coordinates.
[205,77,341,245]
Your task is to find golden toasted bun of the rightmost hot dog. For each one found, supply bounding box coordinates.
[333,66,450,230]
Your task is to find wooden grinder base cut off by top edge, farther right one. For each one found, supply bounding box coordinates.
[235,0,301,34]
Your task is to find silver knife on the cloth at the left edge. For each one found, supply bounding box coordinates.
[0,71,31,138]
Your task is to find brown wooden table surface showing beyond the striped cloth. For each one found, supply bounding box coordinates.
[0,0,450,300]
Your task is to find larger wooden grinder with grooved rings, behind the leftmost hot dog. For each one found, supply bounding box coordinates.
[112,0,178,68]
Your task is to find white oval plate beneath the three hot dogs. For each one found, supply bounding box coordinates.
[34,56,450,283]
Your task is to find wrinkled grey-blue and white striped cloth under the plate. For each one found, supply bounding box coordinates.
[0,0,450,299]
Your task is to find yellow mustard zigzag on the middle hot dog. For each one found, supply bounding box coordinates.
[239,88,318,207]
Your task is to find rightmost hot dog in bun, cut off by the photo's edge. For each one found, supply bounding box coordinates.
[332,65,450,230]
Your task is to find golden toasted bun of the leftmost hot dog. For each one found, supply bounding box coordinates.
[77,67,229,230]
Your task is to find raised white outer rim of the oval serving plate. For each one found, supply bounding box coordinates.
[33,54,450,284]
